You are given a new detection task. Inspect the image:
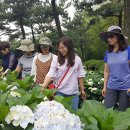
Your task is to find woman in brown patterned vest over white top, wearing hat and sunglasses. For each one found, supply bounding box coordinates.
[31,37,56,84]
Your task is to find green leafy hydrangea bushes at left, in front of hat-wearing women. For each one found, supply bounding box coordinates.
[0,72,46,122]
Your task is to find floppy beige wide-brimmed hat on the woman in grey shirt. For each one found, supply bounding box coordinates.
[17,39,35,51]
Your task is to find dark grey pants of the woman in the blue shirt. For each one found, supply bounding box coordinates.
[104,88,130,111]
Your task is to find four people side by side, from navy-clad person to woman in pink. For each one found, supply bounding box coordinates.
[0,37,86,109]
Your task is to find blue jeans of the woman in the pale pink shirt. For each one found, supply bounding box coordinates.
[56,92,79,110]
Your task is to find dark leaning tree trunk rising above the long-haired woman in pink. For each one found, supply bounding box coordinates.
[51,0,63,37]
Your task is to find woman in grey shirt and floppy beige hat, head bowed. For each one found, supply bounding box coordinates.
[16,39,36,78]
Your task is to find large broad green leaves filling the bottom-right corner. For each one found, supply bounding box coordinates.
[78,100,130,130]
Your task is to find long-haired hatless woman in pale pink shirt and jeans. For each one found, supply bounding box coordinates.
[42,37,86,109]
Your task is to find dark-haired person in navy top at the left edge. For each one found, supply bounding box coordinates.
[0,41,18,76]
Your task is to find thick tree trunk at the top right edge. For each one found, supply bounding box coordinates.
[124,0,130,39]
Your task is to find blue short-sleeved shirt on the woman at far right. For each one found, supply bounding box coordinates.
[104,46,130,90]
